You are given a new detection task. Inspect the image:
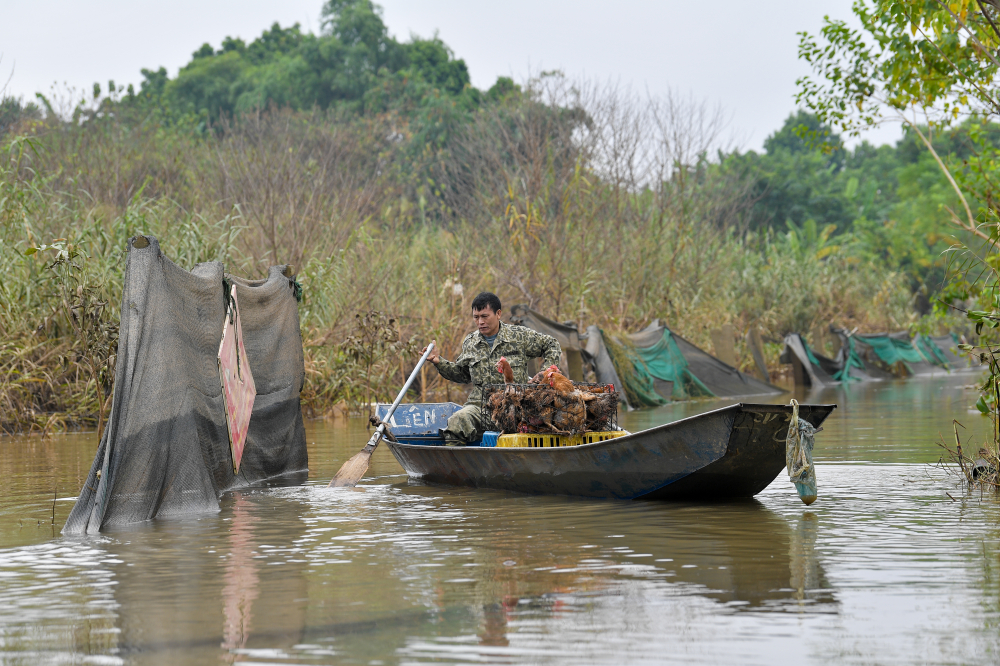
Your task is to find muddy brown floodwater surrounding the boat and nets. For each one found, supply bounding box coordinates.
[0,374,1000,665]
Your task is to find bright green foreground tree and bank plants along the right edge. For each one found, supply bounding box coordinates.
[799,0,1000,489]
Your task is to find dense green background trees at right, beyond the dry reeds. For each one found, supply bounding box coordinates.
[723,111,980,304]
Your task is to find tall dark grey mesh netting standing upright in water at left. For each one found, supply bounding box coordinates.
[63,236,308,534]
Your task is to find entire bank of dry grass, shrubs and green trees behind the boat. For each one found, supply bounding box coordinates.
[0,0,992,431]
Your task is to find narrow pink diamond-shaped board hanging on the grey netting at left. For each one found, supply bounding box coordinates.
[219,284,257,474]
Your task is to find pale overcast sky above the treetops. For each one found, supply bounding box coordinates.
[0,0,899,150]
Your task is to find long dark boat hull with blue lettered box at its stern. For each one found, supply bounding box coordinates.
[376,403,836,500]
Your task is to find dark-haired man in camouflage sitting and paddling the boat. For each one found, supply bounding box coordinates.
[427,292,562,446]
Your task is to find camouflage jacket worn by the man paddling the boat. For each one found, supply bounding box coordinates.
[437,322,562,405]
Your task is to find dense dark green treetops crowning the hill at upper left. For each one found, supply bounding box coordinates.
[125,0,479,123]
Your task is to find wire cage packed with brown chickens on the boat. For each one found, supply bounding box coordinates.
[483,380,618,435]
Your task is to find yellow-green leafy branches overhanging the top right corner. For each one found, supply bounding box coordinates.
[798,0,1000,134]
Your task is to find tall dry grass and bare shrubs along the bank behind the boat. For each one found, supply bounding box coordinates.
[0,81,928,430]
